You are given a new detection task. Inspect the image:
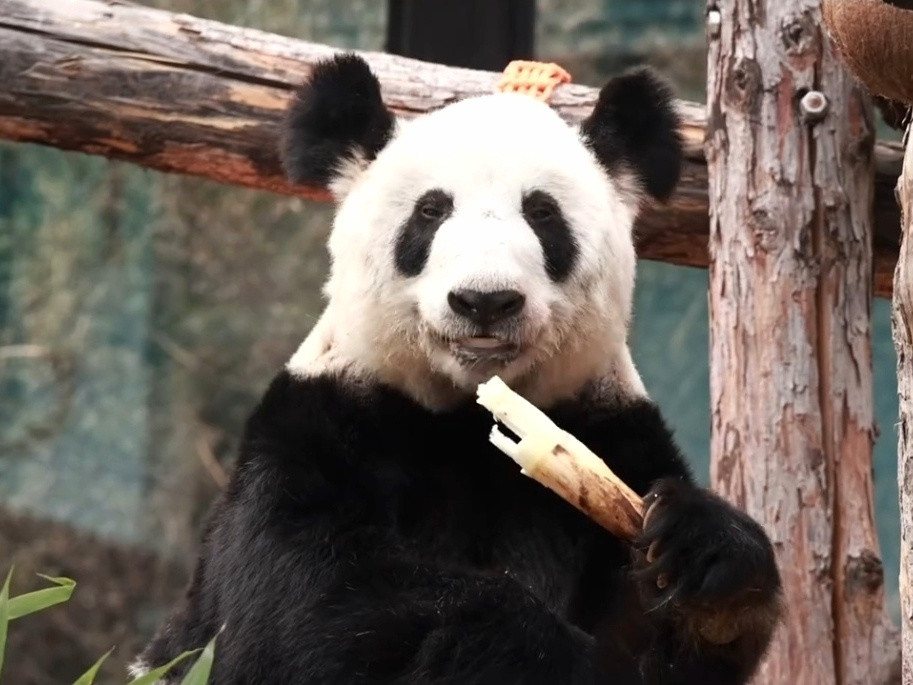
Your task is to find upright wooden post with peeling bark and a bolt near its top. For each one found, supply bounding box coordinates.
[706,0,897,685]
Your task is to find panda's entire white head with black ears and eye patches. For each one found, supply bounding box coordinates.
[282,55,682,408]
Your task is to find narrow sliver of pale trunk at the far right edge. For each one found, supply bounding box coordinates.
[893,124,913,685]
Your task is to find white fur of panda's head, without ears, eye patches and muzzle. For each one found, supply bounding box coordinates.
[288,94,645,408]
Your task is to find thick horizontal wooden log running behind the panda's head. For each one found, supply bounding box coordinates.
[0,0,902,296]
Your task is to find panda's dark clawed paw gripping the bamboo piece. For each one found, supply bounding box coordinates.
[634,478,780,644]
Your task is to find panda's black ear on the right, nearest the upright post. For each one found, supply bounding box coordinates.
[580,68,682,200]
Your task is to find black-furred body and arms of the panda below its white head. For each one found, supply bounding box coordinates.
[143,373,779,685]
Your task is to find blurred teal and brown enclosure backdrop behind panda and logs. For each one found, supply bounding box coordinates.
[0,0,899,685]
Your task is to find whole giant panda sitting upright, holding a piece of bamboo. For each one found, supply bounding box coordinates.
[135,54,781,685]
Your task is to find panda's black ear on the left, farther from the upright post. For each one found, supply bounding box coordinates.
[281,54,395,185]
